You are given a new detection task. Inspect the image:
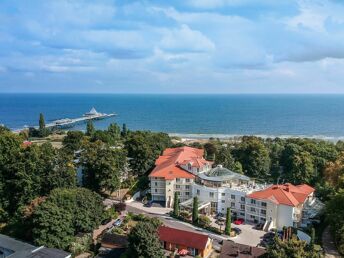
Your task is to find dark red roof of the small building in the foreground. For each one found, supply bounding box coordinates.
[158,226,208,250]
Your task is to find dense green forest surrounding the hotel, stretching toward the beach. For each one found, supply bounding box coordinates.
[0,118,344,253]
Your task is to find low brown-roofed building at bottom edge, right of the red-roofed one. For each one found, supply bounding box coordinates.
[219,241,266,258]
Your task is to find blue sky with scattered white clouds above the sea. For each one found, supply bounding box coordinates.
[0,0,344,94]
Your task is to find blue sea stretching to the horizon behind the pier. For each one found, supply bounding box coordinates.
[0,94,344,140]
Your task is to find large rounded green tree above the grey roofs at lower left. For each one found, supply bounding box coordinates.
[32,188,104,250]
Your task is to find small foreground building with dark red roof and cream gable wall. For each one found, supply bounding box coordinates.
[158,226,213,257]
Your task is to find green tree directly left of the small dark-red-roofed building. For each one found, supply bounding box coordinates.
[128,220,164,258]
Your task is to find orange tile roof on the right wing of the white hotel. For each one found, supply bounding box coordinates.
[248,183,315,207]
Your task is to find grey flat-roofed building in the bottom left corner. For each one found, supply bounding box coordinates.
[0,234,71,258]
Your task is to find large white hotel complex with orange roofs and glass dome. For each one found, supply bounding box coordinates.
[149,147,323,230]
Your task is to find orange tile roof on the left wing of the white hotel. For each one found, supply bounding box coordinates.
[149,146,206,180]
